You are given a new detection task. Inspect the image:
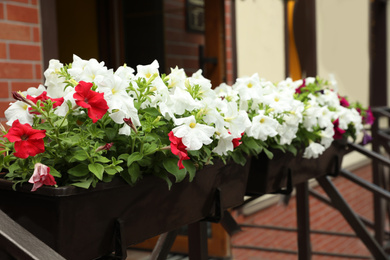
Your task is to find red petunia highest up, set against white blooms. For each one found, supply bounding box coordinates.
[73,81,108,123]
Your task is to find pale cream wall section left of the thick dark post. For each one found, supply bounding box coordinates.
[235,0,285,81]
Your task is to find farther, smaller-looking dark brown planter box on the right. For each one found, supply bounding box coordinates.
[247,140,347,195]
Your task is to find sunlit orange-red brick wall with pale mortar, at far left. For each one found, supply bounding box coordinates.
[0,0,43,121]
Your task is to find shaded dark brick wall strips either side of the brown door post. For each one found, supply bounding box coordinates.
[164,0,233,84]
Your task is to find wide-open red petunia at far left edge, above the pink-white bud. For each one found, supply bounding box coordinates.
[4,120,46,159]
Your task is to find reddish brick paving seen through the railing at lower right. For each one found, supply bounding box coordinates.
[232,165,373,260]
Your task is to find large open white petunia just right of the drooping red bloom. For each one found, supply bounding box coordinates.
[172,116,215,150]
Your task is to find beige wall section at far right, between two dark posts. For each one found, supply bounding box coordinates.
[316,0,369,105]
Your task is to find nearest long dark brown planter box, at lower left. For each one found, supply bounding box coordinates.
[0,162,249,260]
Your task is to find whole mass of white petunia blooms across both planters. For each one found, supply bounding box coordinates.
[5,55,363,158]
